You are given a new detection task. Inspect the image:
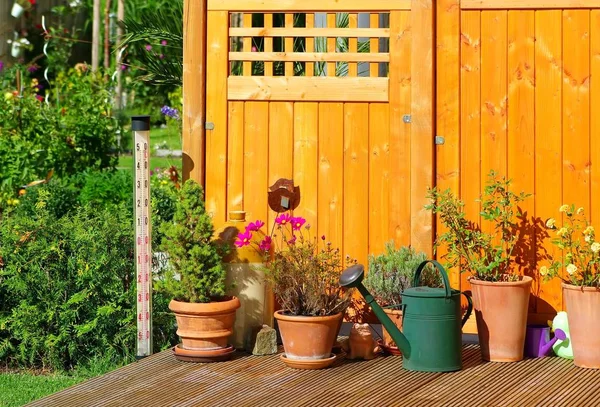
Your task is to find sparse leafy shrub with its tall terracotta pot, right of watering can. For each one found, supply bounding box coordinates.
[426,172,532,362]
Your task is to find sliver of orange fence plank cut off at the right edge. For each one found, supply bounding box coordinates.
[589,10,600,226]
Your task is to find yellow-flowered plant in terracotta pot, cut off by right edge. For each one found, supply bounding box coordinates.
[540,205,600,369]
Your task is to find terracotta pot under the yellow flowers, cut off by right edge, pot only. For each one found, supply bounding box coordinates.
[562,283,600,369]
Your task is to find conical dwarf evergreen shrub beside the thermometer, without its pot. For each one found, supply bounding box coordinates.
[162,179,225,302]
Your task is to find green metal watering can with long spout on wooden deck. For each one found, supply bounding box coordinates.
[340,260,473,372]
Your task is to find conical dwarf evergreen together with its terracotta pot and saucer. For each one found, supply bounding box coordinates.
[161,180,240,361]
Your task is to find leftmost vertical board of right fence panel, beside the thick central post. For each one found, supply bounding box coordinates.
[436,0,460,288]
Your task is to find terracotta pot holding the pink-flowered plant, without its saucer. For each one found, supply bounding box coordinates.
[274,310,342,360]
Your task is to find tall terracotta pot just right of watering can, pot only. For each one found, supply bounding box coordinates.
[469,276,533,362]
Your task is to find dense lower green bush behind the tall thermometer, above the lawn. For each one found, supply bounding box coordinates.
[0,189,175,370]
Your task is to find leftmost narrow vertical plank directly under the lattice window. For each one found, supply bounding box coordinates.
[227,102,244,214]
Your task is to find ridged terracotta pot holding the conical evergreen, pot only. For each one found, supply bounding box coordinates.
[169,297,240,350]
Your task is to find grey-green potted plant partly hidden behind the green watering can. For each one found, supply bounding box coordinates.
[363,241,441,355]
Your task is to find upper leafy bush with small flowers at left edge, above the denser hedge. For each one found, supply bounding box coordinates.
[0,66,118,211]
